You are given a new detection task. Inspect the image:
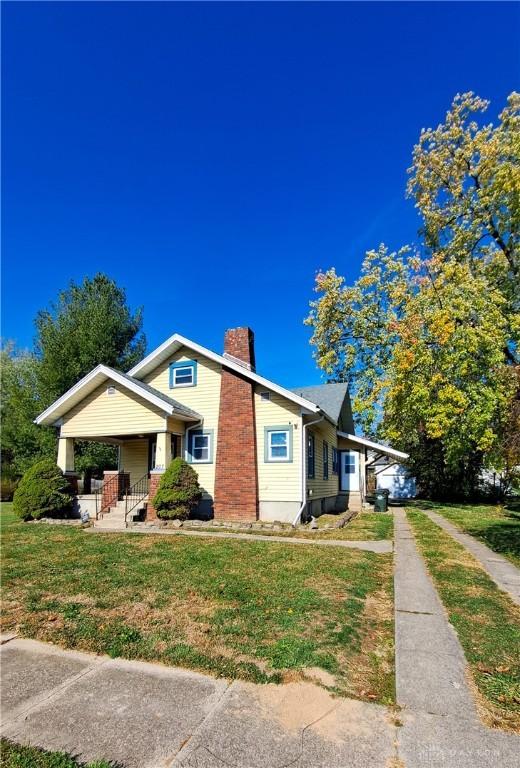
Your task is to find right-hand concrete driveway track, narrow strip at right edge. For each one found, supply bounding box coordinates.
[421,509,520,605]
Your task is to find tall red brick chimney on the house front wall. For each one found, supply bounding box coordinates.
[214,328,258,520]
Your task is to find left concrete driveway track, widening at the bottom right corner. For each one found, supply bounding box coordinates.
[394,509,520,768]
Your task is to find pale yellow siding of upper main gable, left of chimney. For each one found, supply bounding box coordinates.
[144,348,221,497]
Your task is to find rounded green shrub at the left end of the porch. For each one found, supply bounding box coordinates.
[13,459,72,520]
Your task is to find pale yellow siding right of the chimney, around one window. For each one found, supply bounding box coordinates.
[255,385,302,502]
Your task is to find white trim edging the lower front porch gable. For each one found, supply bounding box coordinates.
[34,365,175,425]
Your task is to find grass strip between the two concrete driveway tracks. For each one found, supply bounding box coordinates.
[407,510,520,733]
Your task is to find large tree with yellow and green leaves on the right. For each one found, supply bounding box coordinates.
[306,93,520,497]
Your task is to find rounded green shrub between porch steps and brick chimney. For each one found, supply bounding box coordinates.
[152,458,202,520]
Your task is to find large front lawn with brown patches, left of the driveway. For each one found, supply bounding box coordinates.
[2,505,394,703]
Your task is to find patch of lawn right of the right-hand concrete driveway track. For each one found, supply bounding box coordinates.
[414,501,520,568]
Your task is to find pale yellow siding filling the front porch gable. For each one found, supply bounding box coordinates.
[61,381,166,437]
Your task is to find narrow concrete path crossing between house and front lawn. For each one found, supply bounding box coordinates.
[84,527,393,554]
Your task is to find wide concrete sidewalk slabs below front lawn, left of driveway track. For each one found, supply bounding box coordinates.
[0,639,396,768]
